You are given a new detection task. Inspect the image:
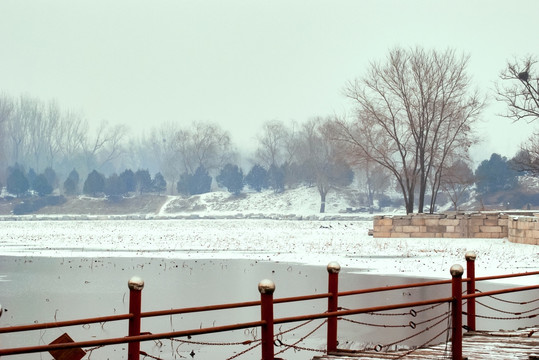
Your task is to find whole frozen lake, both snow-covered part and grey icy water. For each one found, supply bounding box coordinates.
[0,220,537,360]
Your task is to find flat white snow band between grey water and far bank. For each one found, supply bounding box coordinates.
[0,220,539,278]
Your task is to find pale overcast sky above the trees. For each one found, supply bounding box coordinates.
[0,0,539,164]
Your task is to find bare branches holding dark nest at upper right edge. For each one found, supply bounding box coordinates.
[496,55,539,122]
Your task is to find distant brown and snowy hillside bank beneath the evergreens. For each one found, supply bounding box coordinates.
[0,178,539,216]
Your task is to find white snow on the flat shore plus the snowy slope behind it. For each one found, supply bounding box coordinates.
[0,187,539,278]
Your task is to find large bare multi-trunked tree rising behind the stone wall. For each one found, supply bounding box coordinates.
[337,47,484,213]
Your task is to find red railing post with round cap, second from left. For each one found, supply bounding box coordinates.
[258,279,275,360]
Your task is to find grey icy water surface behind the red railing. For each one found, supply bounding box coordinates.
[0,257,536,360]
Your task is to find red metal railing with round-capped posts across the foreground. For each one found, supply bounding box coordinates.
[0,253,539,360]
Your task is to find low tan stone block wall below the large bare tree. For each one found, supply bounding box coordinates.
[372,212,539,245]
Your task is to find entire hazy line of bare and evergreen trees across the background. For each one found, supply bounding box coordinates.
[0,48,539,212]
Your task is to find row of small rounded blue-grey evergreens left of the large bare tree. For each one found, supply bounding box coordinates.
[6,156,354,207]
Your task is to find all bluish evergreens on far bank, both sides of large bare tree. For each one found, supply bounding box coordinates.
[0,150,529,208]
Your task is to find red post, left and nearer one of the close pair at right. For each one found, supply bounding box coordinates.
[450,264,464,360]
